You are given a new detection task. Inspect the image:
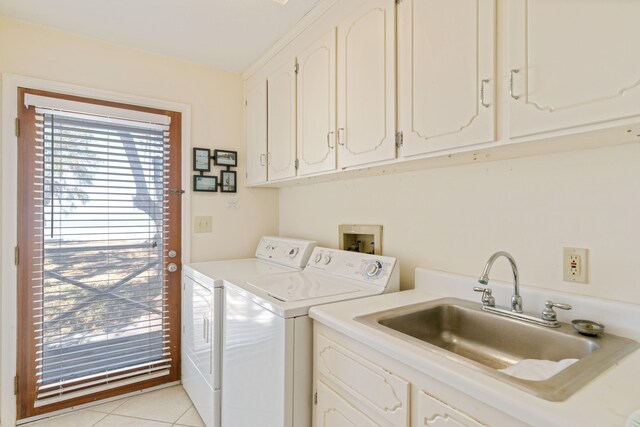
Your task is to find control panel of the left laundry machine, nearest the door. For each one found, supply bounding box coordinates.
[256,236,316,268]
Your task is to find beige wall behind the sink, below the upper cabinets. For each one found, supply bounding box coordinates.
[280,144,640,309]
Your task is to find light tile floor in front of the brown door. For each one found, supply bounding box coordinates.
[24,385,204,427]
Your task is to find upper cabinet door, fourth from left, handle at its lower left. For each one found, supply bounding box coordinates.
[337,0,396,168]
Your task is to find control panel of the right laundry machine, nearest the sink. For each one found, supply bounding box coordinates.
[306,247,399,292]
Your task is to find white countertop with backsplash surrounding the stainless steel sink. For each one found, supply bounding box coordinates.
[310,270,640,427]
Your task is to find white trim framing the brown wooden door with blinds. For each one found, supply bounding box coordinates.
[0,73,191,426]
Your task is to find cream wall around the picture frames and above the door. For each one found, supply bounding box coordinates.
[0,17,278,261]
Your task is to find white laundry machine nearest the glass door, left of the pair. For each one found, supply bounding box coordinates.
[181,236,315,427]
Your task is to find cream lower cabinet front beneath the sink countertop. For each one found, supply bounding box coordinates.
[313,322,527,427]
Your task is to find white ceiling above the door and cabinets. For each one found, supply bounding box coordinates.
[0,0,318,72]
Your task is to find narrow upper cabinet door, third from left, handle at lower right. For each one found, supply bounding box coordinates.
[298,29,336,175]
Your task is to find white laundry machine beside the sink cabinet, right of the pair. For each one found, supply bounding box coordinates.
[222,247,399,427]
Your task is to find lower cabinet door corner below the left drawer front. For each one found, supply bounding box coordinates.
[314,381,377,427]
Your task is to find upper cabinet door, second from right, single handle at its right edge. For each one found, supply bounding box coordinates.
[398,0,495,156]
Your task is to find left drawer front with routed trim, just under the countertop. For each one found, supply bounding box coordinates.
[316,334,410,426]
